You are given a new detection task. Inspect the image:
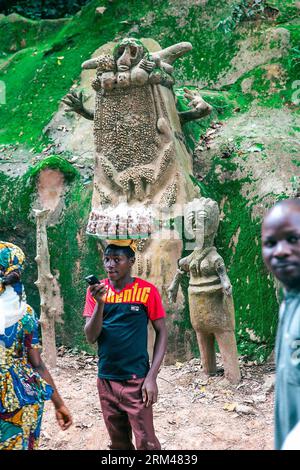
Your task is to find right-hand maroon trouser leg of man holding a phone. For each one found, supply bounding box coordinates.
[120,379,161,450]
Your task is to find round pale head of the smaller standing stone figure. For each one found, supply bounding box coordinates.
[184,197,220,240]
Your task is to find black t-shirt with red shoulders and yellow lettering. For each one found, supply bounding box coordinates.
[83,277,166,381]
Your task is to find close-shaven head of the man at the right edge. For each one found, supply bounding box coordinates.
[262,199,300,290]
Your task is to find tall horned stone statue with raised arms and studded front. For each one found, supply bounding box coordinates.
[64,38,211,295]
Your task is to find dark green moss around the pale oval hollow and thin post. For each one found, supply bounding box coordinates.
[0,155,99,352]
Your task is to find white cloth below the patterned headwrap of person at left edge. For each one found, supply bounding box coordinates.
[0,286,27,335]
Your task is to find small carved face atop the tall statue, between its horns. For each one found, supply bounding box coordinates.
[113,38,148,72]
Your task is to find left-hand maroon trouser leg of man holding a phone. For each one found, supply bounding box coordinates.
[97,378,134,450]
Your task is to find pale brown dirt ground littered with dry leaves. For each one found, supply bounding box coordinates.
[40,349,274,450]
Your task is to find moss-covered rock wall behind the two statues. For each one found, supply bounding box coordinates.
[0,0,300,360]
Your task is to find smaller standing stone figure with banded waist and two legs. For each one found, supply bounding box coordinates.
[169,197,241,384]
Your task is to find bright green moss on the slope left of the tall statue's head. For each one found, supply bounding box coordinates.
[0,1,157,149]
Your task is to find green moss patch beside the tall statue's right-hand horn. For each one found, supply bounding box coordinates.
[139,0,239,86]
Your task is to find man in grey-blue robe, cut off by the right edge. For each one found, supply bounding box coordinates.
[262,199,300,449]
